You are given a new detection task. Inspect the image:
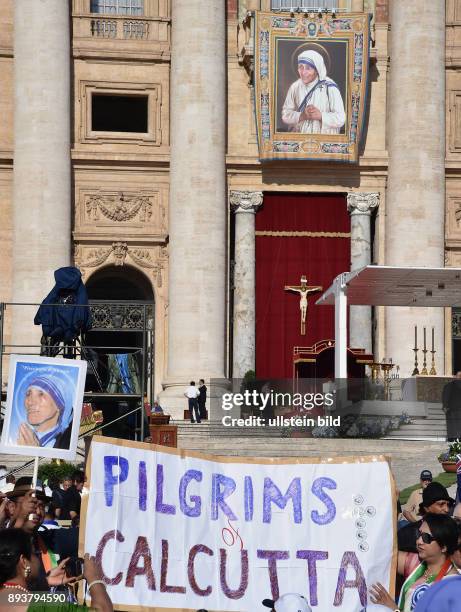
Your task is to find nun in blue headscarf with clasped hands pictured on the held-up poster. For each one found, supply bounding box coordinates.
[17,375,73,449]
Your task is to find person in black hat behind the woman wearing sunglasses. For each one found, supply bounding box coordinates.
[397,482,455,552]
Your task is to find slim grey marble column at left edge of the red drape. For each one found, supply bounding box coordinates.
[230,191,263,378]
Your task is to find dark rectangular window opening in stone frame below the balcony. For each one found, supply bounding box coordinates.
[91,94,149,133]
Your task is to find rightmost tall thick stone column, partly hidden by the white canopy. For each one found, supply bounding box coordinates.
[384,0,449,377]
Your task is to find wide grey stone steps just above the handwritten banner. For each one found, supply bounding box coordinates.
[0,420,447,489]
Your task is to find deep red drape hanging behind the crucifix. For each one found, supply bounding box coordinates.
[256,193,350,378]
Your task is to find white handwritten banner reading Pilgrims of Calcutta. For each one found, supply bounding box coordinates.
[80,437,395,612]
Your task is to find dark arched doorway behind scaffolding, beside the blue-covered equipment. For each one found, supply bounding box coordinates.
[86,266,155,439]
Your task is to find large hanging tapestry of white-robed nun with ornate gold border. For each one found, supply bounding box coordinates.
[254,12,369,162]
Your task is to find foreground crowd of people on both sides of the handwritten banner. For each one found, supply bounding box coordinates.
[0,462,461,612]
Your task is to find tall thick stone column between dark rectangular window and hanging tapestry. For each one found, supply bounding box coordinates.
[162,0,227,417]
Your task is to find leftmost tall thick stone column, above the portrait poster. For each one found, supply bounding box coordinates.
[11,0,71,344]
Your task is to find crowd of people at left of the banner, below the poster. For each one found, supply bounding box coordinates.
[0,471,113,612]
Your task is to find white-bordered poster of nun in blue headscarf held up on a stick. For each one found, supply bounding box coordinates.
[0,355,87,460]
